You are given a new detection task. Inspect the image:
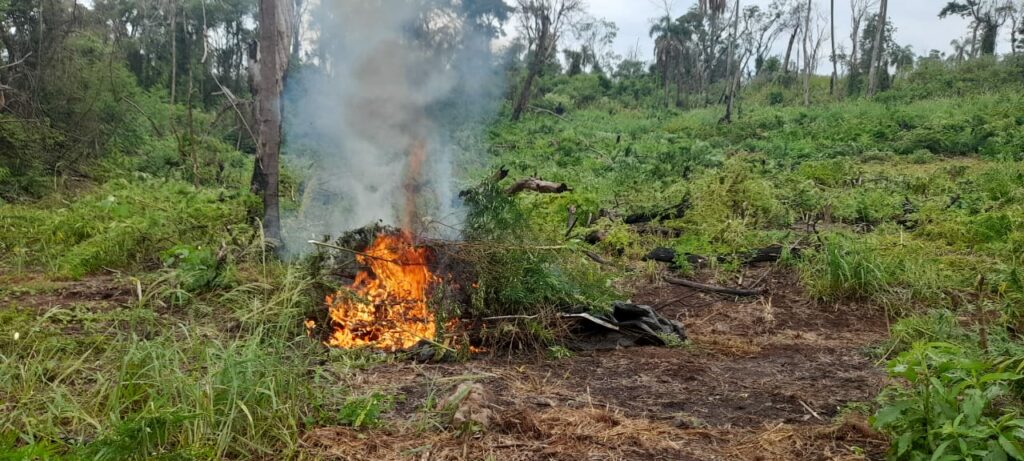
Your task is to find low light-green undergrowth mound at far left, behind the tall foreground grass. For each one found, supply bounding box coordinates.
[0,180,253,277]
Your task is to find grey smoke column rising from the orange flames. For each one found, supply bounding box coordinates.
[285,0,502,248]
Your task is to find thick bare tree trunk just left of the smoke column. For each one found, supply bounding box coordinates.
[252,0,292,244]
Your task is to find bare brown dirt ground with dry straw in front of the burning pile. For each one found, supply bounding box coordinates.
[303,267,887,461]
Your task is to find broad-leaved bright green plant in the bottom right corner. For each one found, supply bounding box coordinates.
[871,342,1024,460]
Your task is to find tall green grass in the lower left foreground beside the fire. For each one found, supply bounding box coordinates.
[0,267,327,460]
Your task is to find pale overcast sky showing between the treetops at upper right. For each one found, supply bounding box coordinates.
[587,0,1010,67]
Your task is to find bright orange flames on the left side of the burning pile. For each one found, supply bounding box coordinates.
[325,233,437,351]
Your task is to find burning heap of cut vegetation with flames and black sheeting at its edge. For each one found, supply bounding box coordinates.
[306,172,685,352]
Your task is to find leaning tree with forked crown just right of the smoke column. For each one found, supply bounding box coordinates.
[512,0,584,121]
